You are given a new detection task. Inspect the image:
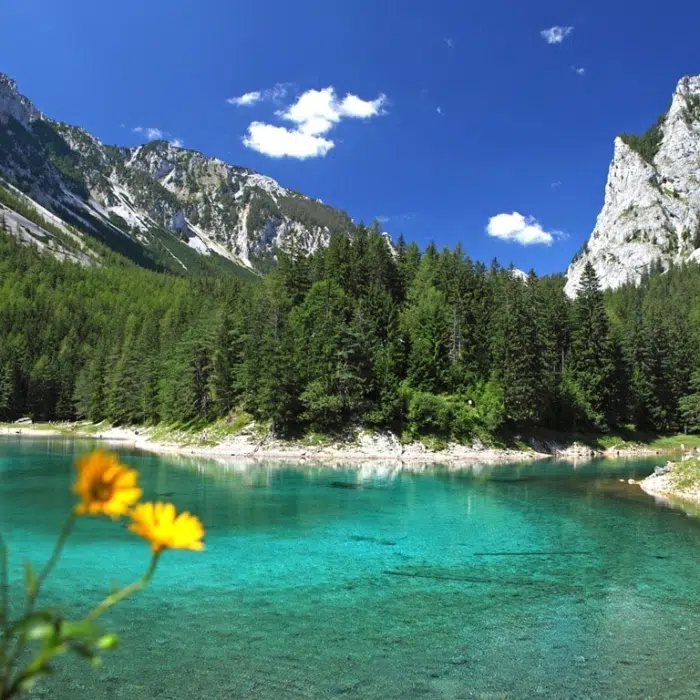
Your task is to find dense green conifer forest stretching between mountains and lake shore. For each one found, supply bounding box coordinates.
[0,219,700,441]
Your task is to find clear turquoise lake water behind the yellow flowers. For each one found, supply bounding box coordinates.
[0,439,700,700]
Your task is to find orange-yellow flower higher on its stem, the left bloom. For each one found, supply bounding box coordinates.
[73,450,142,518]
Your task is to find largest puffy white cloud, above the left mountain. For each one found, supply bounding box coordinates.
[243,87,387,159]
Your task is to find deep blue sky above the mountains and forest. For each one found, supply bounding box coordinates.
[0,0,700,274]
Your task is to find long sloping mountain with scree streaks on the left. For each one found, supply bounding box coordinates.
[0,73,354,272]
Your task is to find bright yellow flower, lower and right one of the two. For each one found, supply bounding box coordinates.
[129,503,204,553]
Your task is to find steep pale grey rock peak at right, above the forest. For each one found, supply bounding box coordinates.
[566,76,700,296]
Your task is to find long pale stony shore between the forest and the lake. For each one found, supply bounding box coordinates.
[0,423,680,468]
